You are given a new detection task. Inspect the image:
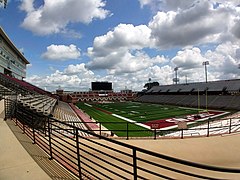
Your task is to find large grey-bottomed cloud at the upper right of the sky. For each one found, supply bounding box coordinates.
[149,1,234,49]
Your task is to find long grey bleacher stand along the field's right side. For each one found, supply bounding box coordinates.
[135,80,240,110]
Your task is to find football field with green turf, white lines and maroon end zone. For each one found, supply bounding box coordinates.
[78,102,227,136]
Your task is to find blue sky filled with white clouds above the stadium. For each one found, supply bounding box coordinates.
[0,0,240,91]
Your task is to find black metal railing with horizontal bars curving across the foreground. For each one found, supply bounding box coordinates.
[12,116,240,179]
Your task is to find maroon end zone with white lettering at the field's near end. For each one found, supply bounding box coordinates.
[144,111,226,129]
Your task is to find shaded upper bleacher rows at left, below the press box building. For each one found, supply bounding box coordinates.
[0,73,58,121]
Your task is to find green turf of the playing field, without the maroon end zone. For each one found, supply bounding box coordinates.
[77,102,198,137]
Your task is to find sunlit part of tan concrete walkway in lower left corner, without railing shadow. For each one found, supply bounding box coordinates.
[0,119,51,180]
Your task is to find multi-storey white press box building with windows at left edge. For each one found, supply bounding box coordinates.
[0,27,29,79]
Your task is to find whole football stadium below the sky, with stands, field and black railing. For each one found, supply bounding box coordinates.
[0,25,240,179]
